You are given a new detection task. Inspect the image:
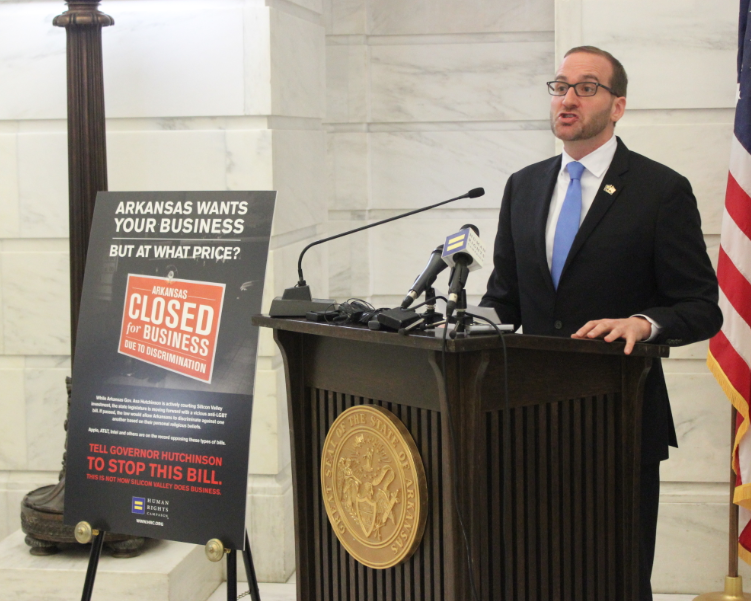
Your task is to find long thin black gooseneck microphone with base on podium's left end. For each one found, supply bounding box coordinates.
[269,188,485,317]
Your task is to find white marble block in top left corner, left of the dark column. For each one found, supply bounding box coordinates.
[0,2,66,120]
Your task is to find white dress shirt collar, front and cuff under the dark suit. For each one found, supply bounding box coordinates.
[545,134,662,341]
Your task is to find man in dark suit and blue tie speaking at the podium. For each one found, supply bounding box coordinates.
[481,46,722,601]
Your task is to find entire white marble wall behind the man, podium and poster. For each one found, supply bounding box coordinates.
[0,0,737,593]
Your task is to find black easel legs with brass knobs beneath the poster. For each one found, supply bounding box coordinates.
[75,522,261,601]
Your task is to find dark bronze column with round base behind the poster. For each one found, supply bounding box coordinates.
[21,0,143,557]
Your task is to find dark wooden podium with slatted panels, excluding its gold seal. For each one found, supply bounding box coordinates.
[253,316,668,601]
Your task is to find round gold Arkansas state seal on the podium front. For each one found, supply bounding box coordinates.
[321,405,428,569]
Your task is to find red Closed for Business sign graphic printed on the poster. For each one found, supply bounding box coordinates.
[118,274,224,383]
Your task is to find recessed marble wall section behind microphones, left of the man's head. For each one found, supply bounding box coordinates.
[326,0,554,305]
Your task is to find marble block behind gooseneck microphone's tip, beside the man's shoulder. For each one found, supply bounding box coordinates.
[370,130,553,209]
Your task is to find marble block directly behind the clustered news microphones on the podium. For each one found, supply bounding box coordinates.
[370,218,498,300]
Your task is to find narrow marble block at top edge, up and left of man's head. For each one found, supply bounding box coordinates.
[368,0,554,35]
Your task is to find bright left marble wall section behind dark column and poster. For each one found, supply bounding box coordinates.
[0,0,327,581]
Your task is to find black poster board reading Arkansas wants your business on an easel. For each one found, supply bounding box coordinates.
[64,192,276,549]
